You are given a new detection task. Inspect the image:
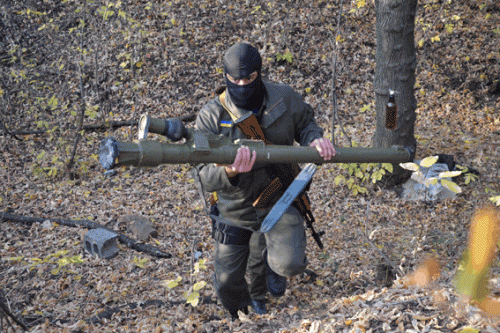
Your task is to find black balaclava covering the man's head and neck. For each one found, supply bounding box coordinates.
[224,43,264,113]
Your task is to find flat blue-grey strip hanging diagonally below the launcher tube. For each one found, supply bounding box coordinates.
[260,163,318,233]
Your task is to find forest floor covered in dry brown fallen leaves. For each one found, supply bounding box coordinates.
[0,0,500,332]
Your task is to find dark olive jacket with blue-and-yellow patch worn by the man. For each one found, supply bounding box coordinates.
[195,82,323,230]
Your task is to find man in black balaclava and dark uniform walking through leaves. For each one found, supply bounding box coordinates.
[195,43,335,319]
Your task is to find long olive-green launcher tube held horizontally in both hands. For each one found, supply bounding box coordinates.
[99,131,412,169]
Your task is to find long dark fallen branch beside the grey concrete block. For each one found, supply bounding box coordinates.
[0,212,172,258]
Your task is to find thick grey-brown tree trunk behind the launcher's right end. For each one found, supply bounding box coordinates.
[372,0,417,185]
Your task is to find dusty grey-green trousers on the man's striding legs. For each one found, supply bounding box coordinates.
[214,207,307,311]
